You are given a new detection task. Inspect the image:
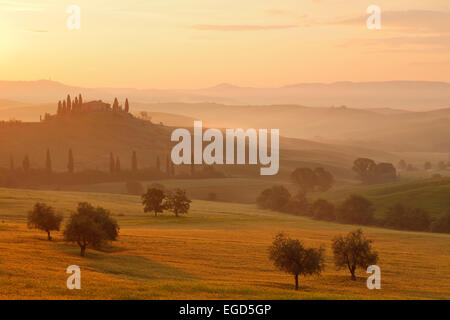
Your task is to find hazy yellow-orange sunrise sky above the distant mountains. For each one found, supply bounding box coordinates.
[0,0,450,88]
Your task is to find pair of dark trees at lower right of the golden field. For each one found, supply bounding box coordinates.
[269,230,378,290]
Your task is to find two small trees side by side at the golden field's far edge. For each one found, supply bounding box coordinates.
[142,188,191,217]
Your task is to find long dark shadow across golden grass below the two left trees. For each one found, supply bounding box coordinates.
[58,244,196,280]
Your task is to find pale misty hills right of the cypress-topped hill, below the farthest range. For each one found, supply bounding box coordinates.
[136,103,450,152]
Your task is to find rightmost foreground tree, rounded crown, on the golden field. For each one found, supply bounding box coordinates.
[332,229,378,280]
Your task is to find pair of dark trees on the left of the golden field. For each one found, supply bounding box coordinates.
[28,202,119,257]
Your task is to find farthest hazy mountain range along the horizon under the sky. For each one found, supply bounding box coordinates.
[0,80,450,111]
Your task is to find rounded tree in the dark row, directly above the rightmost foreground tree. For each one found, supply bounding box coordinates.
[336,195,374,225]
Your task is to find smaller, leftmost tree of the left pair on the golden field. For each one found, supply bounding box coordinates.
[28,202,63,240]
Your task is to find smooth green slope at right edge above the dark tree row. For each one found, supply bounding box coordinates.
[315,177,450,217]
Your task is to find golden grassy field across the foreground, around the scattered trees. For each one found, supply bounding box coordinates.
[0,189,450,299]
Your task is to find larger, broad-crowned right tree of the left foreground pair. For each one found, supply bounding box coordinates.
[64,202,119,257]
